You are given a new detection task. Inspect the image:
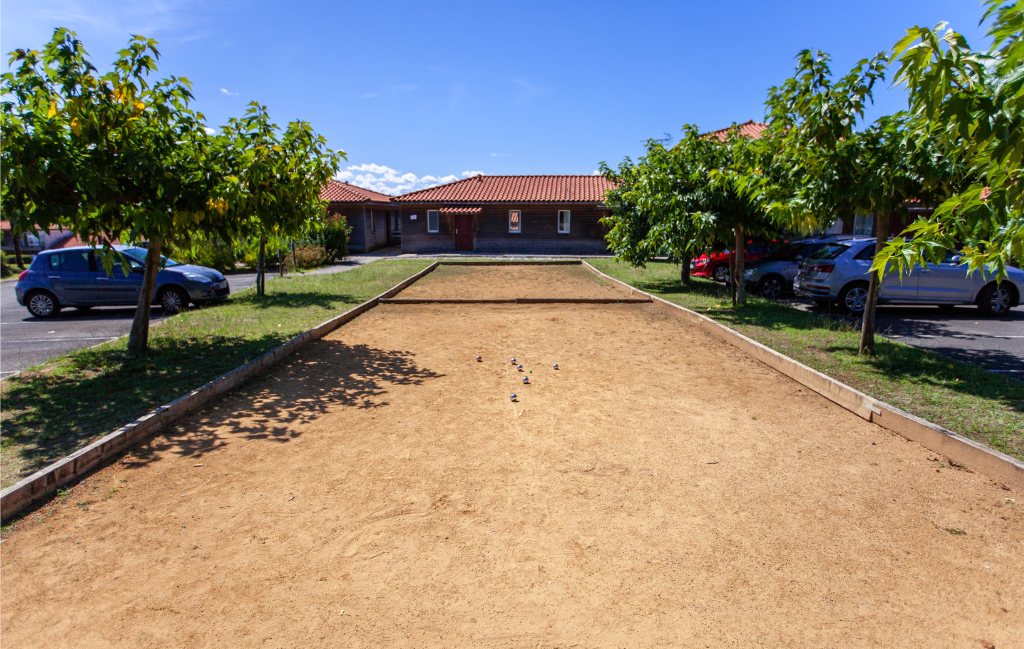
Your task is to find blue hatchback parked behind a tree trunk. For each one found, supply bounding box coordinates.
[14,246,230,317]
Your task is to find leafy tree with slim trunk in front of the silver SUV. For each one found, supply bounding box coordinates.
[742,50,950,355]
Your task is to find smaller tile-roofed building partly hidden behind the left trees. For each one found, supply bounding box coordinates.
[321,180,401,253]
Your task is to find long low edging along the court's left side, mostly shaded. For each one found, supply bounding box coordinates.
[0,262,437,520]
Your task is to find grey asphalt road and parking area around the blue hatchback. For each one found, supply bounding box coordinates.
[0,249,400,379]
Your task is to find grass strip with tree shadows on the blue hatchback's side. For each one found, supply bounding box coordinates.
[0,260,433,487]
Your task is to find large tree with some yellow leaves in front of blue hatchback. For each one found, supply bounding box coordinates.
[0,28,236,353]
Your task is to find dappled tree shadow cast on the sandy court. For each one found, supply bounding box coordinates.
[121,340,443,466]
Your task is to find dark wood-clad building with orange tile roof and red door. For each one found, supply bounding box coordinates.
[394,175,614,255]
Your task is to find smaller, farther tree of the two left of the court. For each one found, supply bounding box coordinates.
[221,101,345,296]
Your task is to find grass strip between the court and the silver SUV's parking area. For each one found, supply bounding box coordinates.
[589,259,1024,460]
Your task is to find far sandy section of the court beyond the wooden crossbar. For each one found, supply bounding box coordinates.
[395,265,641,300]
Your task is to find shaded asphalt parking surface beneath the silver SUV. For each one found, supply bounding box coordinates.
[793,300,1024,380]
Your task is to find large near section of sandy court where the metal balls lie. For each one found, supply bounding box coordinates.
[0,266,1024,648]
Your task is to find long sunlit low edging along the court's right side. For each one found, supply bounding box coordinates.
[583,261,1024,490]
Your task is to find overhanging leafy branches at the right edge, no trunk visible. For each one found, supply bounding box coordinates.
[874,0,1024,278]
